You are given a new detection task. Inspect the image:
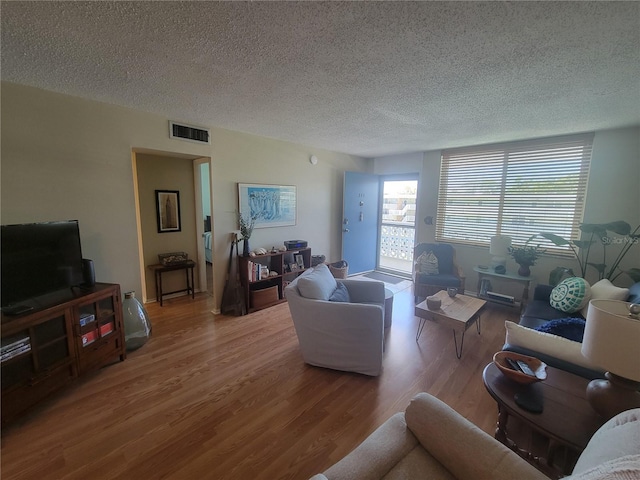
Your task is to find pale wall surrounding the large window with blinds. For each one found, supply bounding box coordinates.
[375,127,640,294]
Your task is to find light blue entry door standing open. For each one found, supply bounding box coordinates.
[342,172,380,275]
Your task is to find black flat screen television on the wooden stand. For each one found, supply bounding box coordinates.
[0,220,83,311]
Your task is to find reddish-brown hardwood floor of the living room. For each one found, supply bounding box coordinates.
[1,289,517,480]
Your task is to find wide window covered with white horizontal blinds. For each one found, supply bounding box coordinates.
[436,134,593,253]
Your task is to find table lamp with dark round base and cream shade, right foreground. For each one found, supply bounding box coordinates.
[582,300,640,419]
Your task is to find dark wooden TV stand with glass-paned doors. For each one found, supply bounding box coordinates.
[0,283,126,424]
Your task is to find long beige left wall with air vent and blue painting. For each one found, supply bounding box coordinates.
[0,82,369,303]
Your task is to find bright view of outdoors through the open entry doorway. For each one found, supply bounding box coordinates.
[378,179,418,277]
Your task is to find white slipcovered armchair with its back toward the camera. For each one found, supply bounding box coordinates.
[285,264,384,376]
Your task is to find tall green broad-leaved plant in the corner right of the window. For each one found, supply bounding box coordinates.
[539,220,640,285]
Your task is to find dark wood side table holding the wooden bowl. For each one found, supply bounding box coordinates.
[482,363,605,478]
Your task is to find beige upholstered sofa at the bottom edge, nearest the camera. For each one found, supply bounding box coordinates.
[311,393,640,480]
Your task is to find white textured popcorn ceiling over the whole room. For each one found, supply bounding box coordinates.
[1,1,640,157]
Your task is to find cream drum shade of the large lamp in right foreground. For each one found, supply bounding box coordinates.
[582,300,640,382]
